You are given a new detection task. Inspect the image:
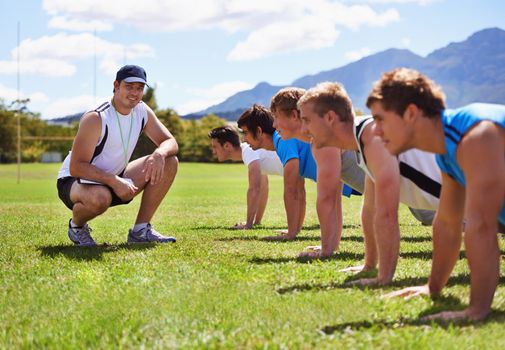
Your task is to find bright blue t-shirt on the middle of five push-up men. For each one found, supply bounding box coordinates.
[273,131,354,197]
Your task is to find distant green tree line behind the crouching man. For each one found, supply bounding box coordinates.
[0,88,227,163]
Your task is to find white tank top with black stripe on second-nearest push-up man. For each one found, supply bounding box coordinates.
[354,116,442,210]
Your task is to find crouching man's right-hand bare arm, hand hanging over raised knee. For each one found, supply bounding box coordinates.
[143,105,179,185]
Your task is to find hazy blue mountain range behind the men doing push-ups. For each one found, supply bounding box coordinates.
[185,28,505,120]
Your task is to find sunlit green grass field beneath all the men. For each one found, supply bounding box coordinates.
[0,163,505,349]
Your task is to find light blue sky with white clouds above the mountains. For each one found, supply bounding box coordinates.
[0,0,505,119]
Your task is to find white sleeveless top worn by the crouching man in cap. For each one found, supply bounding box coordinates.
[58,101,148,179]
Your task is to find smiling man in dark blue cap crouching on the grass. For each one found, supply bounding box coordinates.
[57,65,178,246]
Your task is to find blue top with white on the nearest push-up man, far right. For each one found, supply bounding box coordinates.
[436,103,505,224]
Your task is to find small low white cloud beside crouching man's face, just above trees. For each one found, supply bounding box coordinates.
[42,95,110,119]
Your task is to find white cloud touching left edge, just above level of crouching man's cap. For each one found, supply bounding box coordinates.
[0,33,154,77]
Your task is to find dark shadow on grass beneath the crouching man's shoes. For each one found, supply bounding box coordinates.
[37,243,156,260]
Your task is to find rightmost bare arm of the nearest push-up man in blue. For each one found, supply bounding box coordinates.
[457,122,505,320]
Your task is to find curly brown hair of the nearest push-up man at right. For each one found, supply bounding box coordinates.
[366,68,445,118]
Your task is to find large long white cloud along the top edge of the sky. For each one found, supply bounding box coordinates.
[43,0,398,61]
